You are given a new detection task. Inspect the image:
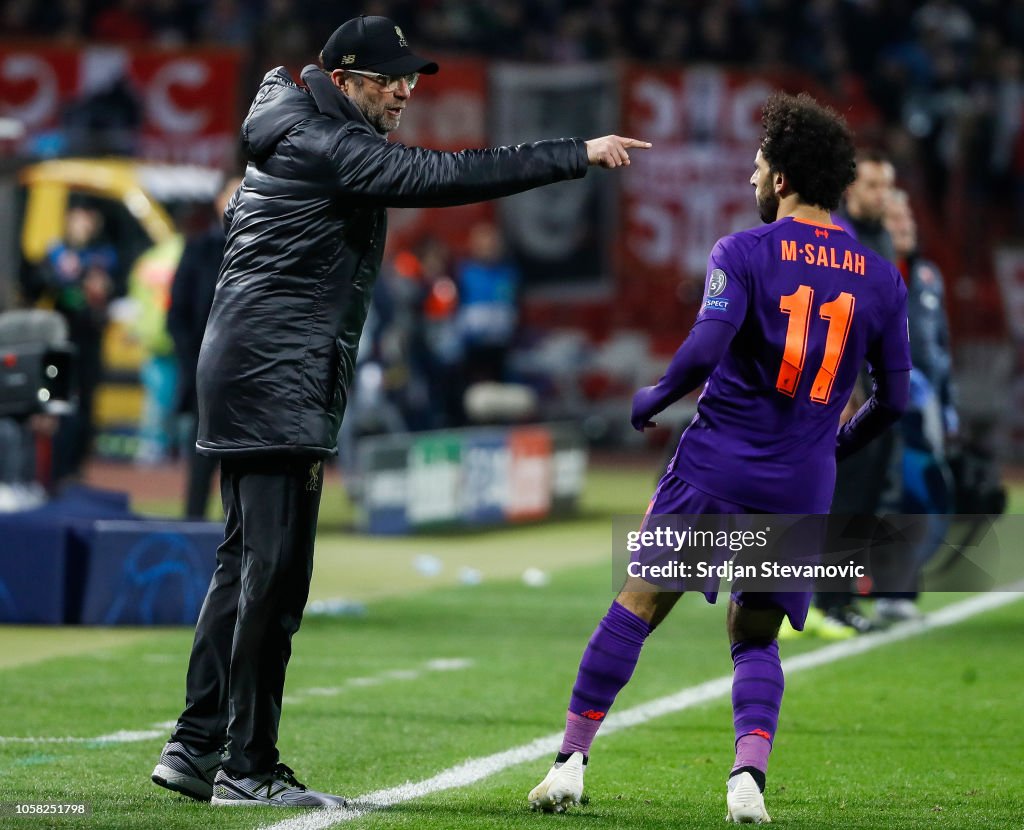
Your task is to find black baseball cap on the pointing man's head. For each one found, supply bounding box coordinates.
[322,15,438,76]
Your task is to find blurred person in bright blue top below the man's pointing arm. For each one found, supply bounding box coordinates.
[456,222,520,384]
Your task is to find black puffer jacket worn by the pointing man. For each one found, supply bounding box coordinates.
[197,67,587,456]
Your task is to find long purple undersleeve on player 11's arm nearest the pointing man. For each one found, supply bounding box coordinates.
[630,318,736,432]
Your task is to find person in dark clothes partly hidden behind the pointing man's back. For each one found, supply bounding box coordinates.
[167,176,242,519]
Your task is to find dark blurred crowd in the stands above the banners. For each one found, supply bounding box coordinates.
[6,0,1024,233]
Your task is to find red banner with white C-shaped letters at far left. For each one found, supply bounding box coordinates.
[0,45,240,167]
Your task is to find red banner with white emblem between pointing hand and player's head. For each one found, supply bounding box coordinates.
[617,67,871,341]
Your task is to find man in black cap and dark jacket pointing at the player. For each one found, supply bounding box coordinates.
[153,11,649,806]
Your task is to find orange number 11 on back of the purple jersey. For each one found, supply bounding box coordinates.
[775,286,855,403]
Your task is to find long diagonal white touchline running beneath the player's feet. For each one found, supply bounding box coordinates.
[263,582,1024,830]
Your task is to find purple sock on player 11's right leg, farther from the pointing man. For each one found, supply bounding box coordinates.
[732,641,784,787]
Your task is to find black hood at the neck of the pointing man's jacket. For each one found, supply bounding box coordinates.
[242,64,376,162]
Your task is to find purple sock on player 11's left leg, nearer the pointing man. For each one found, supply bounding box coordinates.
[561,602,650,755]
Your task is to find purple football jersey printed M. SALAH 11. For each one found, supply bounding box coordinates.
[669,217,910,514]
